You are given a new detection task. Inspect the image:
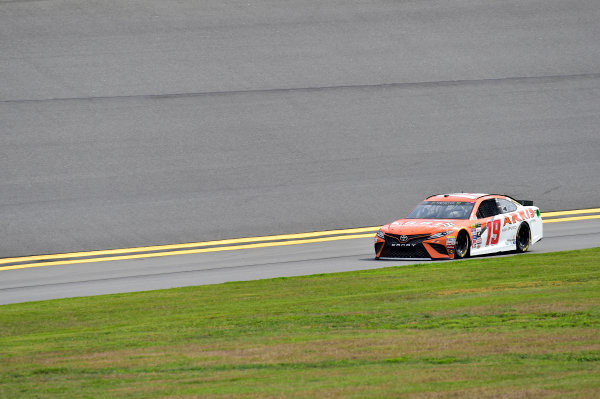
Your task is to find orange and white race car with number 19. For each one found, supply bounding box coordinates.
[375,193,543,259]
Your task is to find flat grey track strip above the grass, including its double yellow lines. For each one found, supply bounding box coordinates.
[0,208,600,304]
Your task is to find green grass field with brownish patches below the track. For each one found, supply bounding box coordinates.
[0,248,600,399]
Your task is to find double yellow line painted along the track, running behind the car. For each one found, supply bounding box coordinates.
[0,208,600,270]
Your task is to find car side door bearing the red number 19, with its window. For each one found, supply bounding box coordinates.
[471,198,504,255]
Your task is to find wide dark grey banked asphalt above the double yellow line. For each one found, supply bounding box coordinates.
[0,0,600,257]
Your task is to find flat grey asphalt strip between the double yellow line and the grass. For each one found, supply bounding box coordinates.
[0,216,600,304]
